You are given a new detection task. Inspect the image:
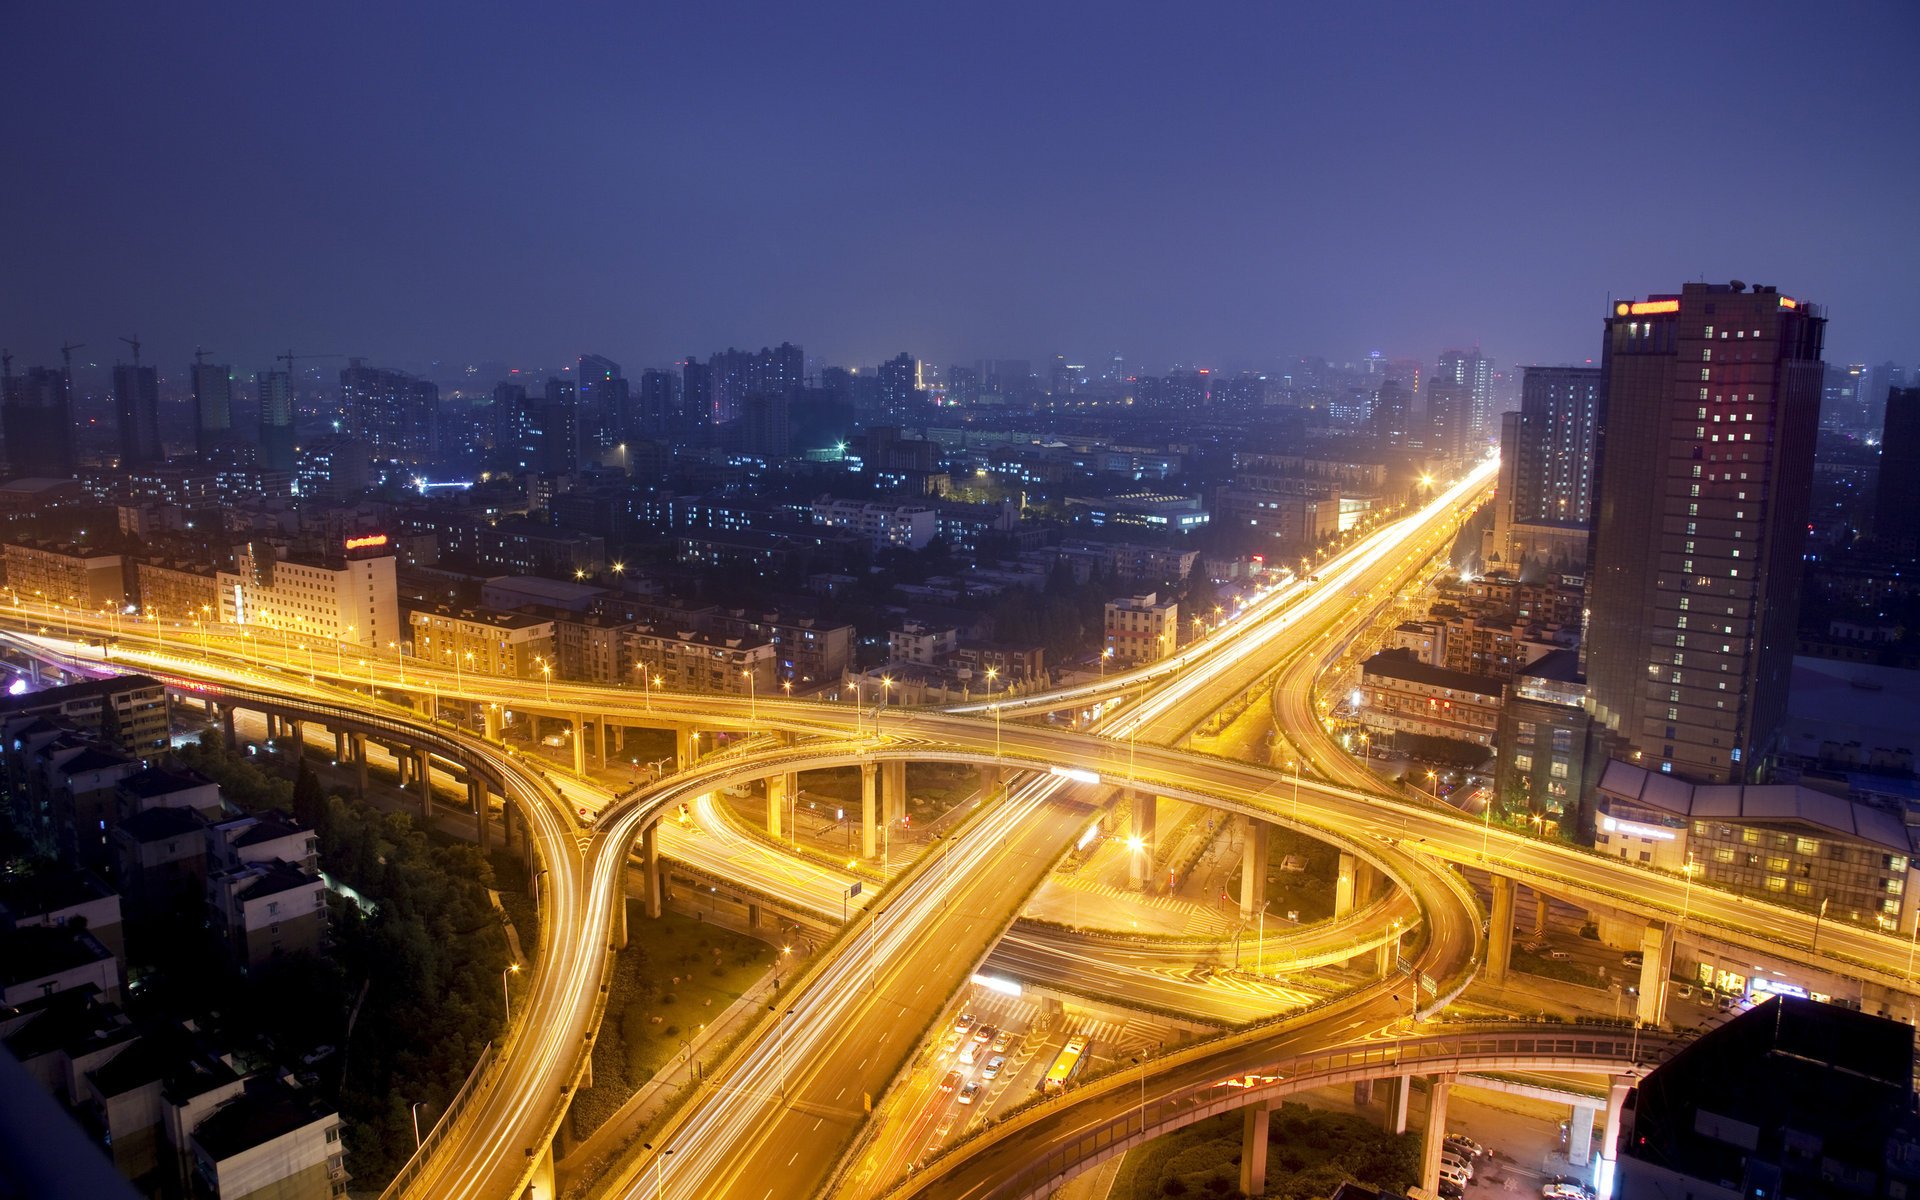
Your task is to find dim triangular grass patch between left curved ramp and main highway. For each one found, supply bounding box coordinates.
[572,900,779,1137]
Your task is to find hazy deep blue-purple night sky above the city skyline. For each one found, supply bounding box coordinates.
[0,0,1920,372]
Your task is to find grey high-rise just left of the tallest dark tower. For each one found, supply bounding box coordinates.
[1488,367,1599,572]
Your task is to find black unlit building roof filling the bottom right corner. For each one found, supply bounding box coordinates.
[1613,995,1920,1200]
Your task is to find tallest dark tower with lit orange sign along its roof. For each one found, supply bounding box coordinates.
[1586,282,1826,783]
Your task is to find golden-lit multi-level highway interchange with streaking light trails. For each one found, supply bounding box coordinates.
[13,451,1910,1198]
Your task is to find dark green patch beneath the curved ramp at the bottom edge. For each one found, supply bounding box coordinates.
[1110,1104,1421,1200]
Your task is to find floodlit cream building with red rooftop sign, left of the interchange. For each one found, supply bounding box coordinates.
[215,534,397,647]
